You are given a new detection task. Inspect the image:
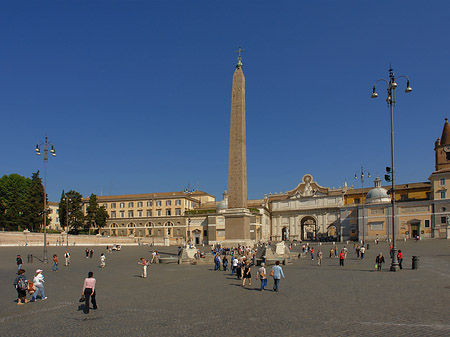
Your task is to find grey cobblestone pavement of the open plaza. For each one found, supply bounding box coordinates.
[0,240,450,336]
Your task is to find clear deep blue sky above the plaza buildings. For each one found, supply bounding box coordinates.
[0,0,450,201]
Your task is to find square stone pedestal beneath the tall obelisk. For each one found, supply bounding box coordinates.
[220,208,254,248]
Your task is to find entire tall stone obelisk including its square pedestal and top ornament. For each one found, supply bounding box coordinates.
[224,48,251,245]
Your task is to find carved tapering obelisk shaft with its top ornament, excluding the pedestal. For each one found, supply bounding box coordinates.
[228,48,247,209]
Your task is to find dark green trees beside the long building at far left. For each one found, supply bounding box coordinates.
[0,171,109,232]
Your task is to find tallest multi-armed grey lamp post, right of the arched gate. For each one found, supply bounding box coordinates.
[372,67,412,271]
